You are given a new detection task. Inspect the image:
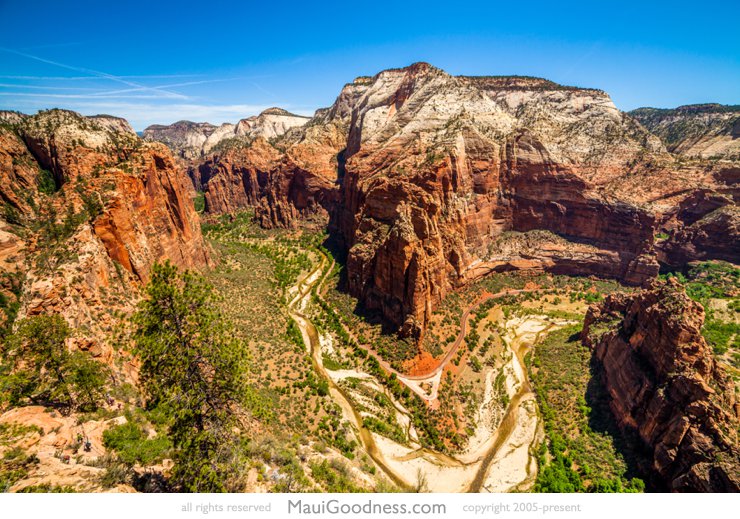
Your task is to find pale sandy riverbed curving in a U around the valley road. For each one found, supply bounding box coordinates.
[293,258,567,492]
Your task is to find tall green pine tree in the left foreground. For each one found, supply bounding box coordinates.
[133,262,246,492]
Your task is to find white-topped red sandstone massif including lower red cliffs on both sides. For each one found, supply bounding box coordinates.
[178,63,740,337]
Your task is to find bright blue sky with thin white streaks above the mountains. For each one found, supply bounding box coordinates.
[0,0,740,130]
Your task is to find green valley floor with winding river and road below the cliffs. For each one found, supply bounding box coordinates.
[199,211,732,492]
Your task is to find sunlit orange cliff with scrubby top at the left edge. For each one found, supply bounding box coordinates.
[0,110,209,355]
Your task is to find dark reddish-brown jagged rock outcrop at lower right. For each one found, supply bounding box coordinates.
[582,281,740,492]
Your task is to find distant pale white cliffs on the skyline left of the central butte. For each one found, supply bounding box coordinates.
[143,108,309,160]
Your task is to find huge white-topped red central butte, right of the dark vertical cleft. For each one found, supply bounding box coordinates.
[328,64,708,333]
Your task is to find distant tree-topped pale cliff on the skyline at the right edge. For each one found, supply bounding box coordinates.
[629,104,740,160]
